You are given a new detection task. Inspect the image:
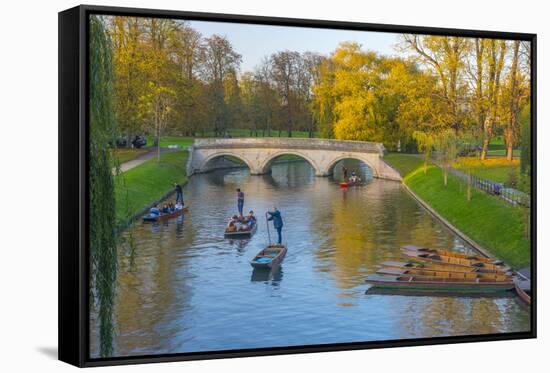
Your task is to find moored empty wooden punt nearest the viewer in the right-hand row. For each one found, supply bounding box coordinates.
[365,275,514,293]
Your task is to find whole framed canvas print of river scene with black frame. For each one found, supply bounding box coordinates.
[59,6,537,367]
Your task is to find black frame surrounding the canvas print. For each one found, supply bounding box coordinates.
[58,5,537,367]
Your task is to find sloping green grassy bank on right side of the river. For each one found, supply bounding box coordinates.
[385,154,530,268]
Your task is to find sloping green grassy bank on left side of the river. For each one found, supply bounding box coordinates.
[115,150,188,221]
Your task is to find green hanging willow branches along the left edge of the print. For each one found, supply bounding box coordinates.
[89,17,117,356]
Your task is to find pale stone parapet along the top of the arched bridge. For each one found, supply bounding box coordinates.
[193,137,385,155]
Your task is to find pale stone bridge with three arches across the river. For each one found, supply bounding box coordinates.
[187,137,401,180]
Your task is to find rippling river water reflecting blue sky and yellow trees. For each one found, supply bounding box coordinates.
[91,161,530,357]
